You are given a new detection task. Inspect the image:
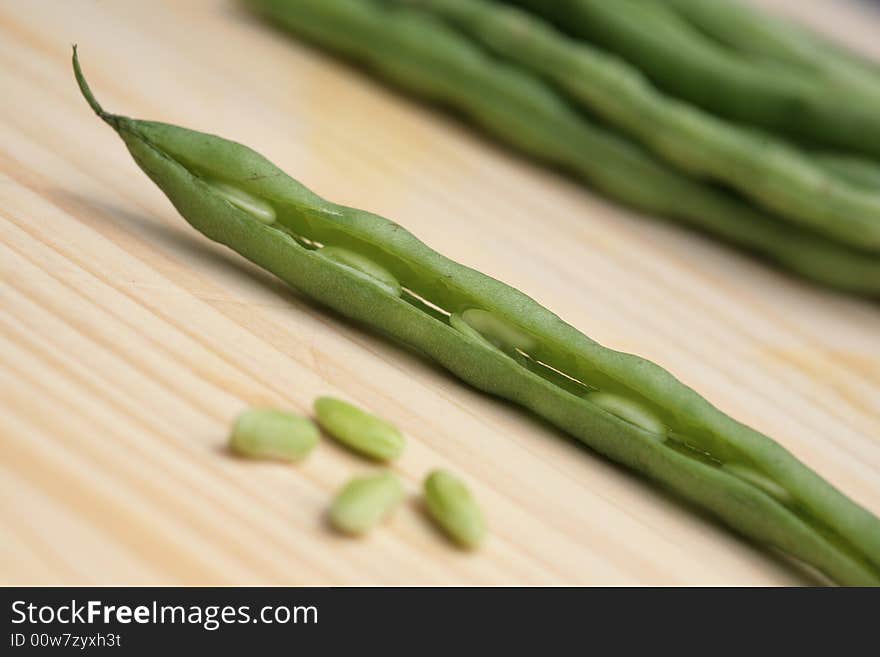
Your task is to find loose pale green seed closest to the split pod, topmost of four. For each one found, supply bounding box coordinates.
[315,397,405,461]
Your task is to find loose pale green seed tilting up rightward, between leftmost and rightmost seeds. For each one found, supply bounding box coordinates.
[330,472,403,535]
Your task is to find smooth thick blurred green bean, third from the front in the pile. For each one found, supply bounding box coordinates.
[504,0,880,158]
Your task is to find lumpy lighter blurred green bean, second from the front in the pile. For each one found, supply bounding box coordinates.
[392,0,880,251]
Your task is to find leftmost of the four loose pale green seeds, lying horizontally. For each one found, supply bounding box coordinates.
[229,408,320,461]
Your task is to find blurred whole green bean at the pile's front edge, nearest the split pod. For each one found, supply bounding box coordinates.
[248,0,880,296]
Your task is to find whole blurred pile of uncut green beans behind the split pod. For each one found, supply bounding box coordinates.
[247,0,880,296]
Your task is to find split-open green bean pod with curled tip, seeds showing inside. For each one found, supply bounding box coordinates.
[74,51,880,585]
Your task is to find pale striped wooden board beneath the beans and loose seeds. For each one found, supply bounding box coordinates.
[0,0,880,585]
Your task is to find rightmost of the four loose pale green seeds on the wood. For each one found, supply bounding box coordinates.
[424,470,486,548]
